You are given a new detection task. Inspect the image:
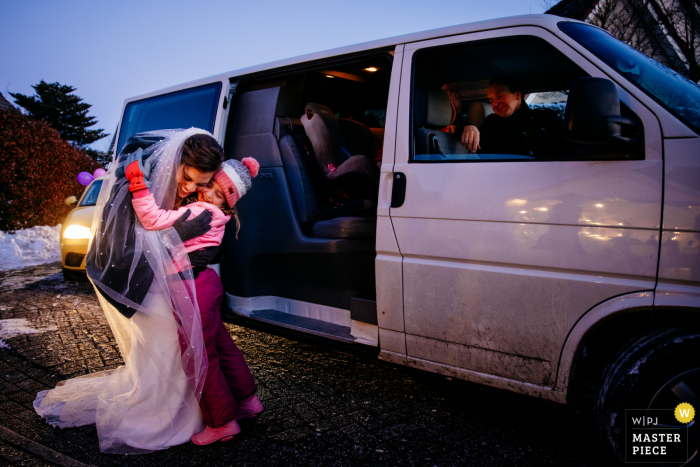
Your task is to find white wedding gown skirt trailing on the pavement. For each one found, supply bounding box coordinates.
[34,280,204,454]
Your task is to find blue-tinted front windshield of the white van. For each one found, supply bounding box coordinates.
[559,22,700,133]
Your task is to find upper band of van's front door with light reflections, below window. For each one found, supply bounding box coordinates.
[392,160,663,229]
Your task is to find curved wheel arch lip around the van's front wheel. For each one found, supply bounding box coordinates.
[554,290,654,392]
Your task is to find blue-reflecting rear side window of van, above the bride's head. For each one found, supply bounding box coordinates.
[117,83,221,154]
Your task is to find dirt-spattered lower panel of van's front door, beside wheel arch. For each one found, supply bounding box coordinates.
[403,258,654,364]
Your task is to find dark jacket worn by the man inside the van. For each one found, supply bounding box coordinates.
[478,102,563,160]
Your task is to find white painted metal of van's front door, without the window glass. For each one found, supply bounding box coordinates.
[390,27,663,387]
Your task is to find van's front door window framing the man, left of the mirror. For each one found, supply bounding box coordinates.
[411,36,586,162]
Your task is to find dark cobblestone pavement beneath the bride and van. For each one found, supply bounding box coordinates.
[0,263,608,467]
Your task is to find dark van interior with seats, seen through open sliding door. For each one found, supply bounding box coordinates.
[221,50,393,345]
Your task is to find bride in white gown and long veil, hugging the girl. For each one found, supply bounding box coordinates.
[34,128,221,454]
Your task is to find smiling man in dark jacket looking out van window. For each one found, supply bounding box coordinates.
[462,78,562,160]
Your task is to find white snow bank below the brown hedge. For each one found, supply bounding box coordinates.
[0,224,61,271]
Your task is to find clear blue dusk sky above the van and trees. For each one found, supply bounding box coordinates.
[0,0,545,150]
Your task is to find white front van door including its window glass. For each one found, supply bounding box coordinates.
[392,27,663,400]
